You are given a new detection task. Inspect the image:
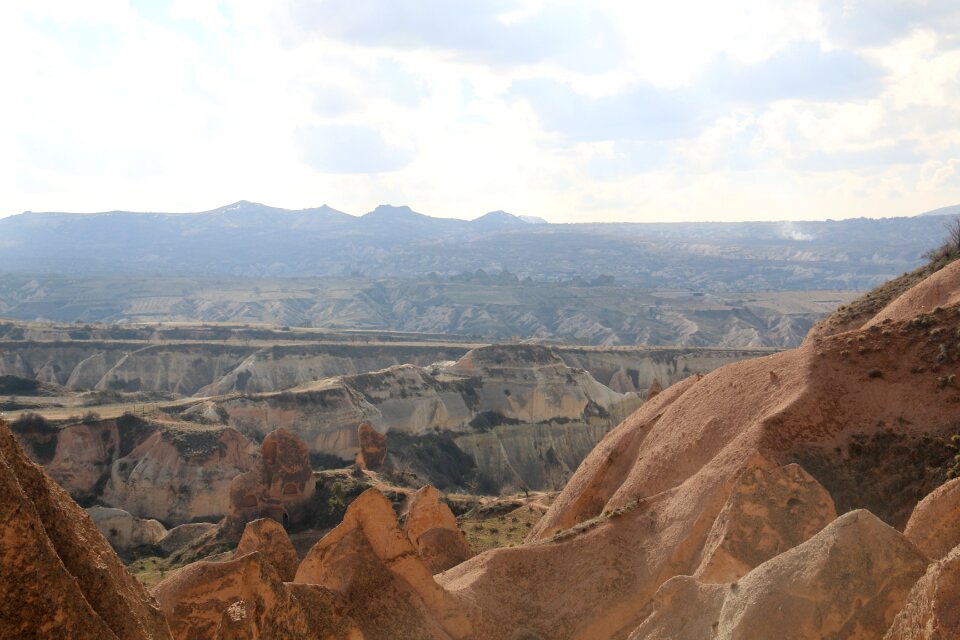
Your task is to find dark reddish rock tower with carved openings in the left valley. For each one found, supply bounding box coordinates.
[228,429,316,524]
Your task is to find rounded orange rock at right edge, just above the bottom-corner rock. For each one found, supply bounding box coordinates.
[903,478,960,560]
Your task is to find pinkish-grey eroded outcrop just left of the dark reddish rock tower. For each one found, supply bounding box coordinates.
[103,424,256,525]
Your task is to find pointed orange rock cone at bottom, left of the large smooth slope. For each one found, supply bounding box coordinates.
[295,489,471,640]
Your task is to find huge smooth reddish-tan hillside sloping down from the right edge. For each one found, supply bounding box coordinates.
[437,268,960,639]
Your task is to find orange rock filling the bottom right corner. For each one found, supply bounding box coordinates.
[884,547,960,640]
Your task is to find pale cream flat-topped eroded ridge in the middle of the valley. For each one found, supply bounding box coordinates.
[220,345,641,491]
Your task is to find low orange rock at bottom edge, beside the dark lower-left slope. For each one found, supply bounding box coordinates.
[153,552,309,640]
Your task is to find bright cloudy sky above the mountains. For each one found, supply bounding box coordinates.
[0,0,960,222]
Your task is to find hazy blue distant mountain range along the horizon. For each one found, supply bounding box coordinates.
[0,201,960,292]
